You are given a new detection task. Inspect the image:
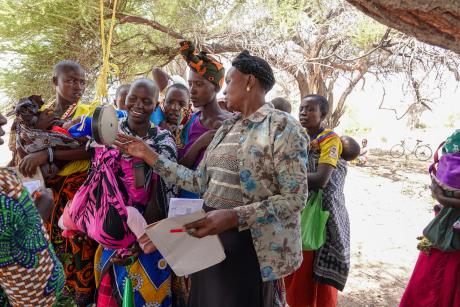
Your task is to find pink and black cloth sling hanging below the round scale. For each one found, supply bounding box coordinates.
[64,147,150,249]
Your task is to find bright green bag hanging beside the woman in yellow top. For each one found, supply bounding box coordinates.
[300,190,329,250]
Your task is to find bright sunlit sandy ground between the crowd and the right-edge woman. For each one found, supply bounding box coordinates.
[339,150,434,307]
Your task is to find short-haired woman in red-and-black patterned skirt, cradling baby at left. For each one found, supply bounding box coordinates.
[16,61,97,306]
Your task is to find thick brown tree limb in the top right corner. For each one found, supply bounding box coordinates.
[347,0,460,54]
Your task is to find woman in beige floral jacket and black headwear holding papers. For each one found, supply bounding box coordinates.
[116,51,308,307]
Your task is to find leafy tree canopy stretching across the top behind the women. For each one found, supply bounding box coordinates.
[0,0,459,126]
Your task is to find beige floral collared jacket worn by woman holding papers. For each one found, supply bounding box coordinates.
[154,105,308,281]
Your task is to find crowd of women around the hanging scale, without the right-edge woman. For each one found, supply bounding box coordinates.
[0,41,458,307]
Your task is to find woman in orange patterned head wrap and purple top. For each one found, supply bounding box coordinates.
[177,41,231,198]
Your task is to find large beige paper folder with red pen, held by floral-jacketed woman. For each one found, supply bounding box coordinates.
[145,211,225,276]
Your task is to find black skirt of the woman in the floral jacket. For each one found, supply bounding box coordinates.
[188,206,274,307]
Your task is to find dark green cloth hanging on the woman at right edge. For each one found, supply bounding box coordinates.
[423,207,460,252]
